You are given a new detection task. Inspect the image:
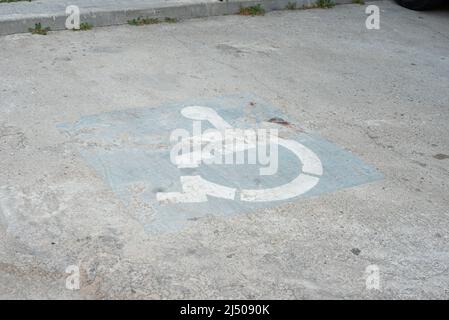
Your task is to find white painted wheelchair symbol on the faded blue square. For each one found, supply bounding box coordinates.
[156,106,323,203]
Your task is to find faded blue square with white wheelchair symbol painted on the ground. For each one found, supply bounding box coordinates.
[59,95,382,233]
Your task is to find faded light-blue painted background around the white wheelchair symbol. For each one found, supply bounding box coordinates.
[59,95,382,232]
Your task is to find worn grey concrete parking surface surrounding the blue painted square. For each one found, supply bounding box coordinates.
[0,1,449,299]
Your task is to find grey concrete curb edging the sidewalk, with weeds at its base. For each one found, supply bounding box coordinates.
[0,0,362,35]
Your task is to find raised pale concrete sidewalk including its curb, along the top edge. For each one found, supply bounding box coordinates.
[0,0,358,35]
